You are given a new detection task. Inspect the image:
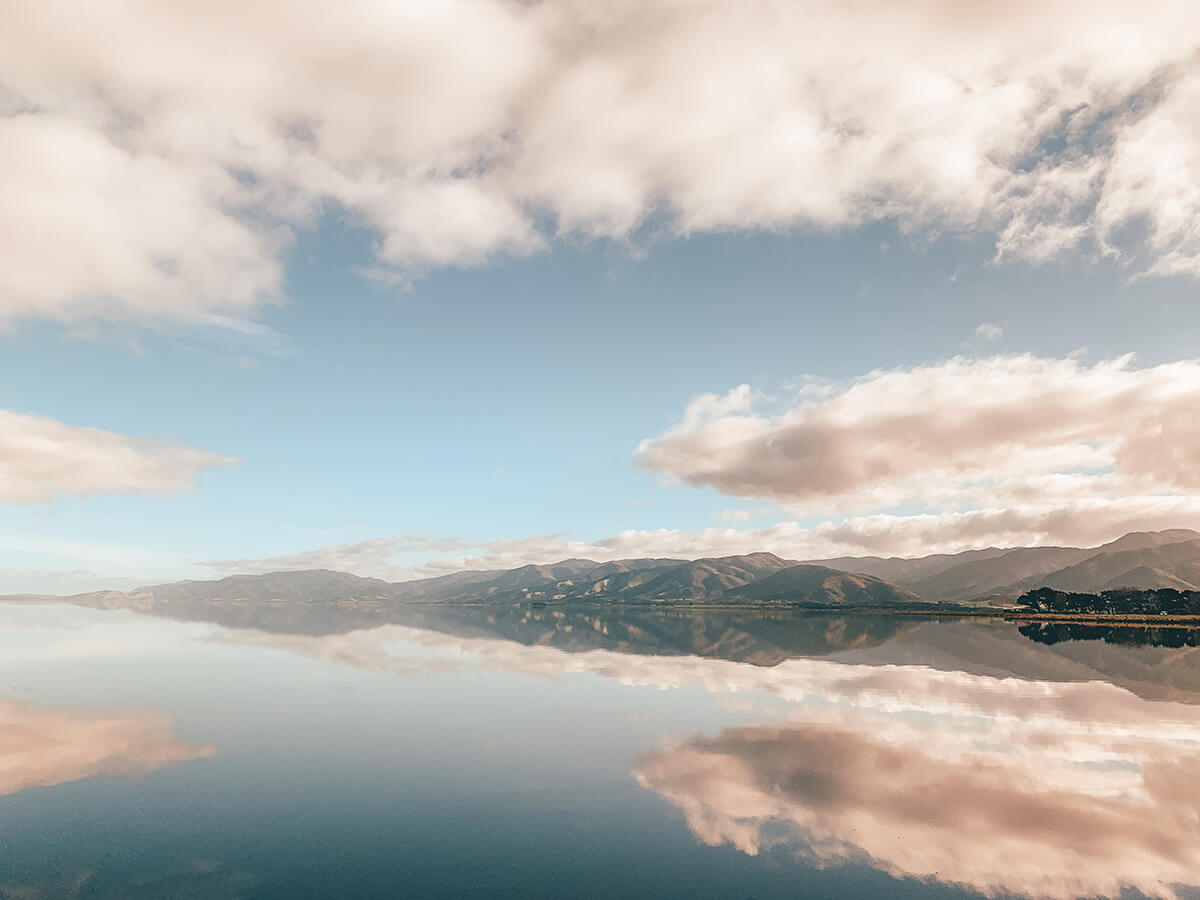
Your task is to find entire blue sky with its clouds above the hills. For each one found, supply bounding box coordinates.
[0,0,1200,593]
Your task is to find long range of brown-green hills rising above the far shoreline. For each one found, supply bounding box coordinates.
[14,529,1200,608]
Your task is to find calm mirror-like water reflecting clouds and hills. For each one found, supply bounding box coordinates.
[0,604,1200,899]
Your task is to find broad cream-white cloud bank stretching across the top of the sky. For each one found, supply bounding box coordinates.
[7,0,1200,320]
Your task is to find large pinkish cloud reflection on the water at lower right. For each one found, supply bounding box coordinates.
[635,662,1200,899]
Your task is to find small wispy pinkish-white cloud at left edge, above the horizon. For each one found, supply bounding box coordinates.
[0,409,238,503]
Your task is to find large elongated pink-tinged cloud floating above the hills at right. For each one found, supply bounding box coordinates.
[637,355,1200,517]
